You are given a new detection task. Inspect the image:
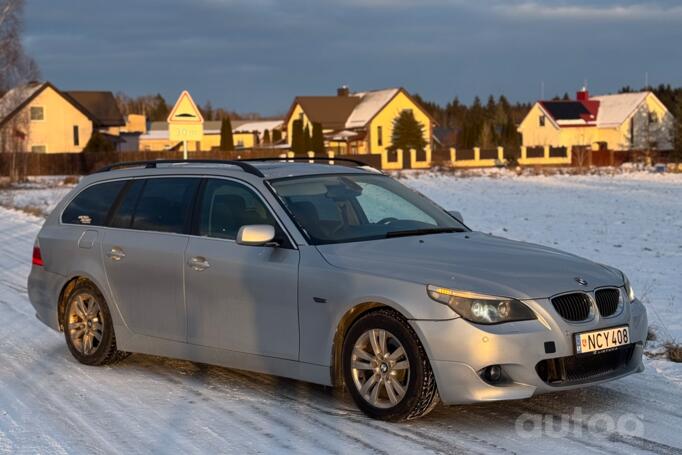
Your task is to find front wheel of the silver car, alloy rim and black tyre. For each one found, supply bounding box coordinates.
[343,309,439,421]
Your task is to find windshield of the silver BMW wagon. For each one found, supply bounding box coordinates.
[271,174,468,245]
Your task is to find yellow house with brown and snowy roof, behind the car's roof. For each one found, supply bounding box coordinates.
[284,86,435,168]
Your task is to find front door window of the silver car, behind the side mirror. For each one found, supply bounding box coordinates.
[199,179,277,240]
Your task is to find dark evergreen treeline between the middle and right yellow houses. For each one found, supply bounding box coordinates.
[415,95,531,148]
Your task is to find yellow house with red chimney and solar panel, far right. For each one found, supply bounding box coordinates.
[518,88,673,150]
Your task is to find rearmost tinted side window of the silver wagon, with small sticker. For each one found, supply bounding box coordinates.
[62,180,126,226]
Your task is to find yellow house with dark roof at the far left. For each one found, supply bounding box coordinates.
[0,82,125,153]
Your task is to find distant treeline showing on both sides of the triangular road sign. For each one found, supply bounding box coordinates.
[116,92,263,122]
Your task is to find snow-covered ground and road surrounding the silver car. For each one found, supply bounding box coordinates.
[0,173,682,454]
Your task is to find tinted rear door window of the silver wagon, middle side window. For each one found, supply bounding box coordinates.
[132,178,199,234]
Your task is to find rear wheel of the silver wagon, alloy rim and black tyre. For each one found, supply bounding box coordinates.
[64,282,128,365]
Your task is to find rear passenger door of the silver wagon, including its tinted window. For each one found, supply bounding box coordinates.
[102,177,200,342]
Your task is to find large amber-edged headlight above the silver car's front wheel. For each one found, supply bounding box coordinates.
[426,285,536,324]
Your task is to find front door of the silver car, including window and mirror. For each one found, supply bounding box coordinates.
[185,179,299,360]
